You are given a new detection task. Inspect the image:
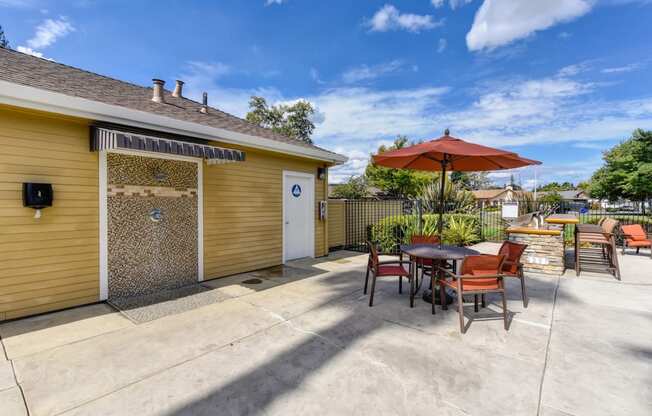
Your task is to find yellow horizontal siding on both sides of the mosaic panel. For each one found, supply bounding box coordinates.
[0,107,328,321]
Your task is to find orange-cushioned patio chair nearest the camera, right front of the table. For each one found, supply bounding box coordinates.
[432,254,508,333]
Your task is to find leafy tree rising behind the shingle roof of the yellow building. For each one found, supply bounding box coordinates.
[246,95,315,143]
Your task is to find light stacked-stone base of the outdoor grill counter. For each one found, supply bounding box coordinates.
[509,233,564,276]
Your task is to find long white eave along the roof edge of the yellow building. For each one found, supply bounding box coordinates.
[0,80,348,165]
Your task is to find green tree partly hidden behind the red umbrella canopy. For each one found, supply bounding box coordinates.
[365,135,438,198]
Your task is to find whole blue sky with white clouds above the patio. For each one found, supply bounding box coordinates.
[0,0,652,186]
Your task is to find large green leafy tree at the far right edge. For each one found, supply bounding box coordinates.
[589,129,652,208]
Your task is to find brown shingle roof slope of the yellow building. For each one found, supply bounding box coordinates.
[0,48,335,158]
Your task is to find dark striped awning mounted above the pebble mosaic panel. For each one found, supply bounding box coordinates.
[91,127,245,164]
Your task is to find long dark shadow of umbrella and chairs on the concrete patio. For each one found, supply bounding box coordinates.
[166,260,573,415]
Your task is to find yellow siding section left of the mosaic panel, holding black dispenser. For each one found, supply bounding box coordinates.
[0,107,99,320]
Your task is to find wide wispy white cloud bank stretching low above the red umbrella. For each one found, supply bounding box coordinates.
[180,62,652,183]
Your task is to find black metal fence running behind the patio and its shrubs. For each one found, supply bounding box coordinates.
[344,199,652,253]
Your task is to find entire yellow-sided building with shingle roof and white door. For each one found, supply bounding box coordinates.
[0,48,346,321]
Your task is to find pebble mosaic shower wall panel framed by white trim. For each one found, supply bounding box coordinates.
[107,153,198,298]
